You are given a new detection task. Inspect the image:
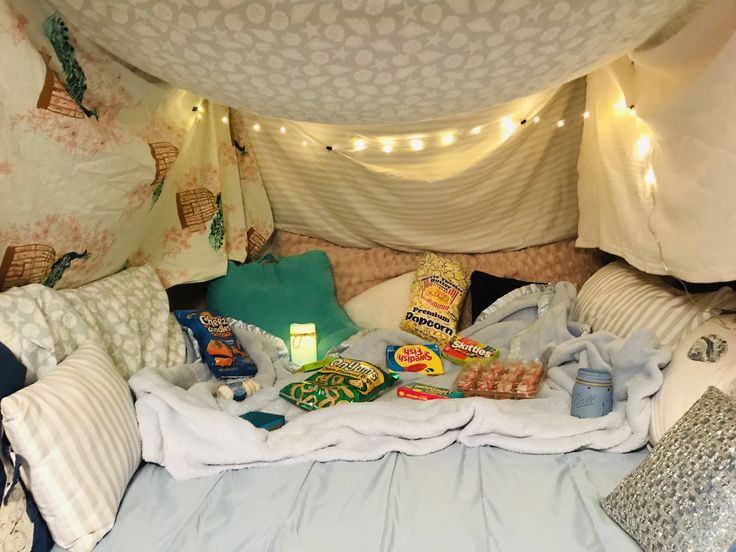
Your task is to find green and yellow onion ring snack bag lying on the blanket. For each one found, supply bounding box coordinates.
[279,358,399,410]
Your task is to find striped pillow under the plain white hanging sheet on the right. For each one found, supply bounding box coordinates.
[573,261,736,347]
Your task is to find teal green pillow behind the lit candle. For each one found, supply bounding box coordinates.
[207,251,358,358]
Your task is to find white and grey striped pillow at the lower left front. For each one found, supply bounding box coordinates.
[0,342,141,552]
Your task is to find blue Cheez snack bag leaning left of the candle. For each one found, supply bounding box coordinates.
[174,310,258,378]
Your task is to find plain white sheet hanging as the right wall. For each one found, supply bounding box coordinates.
[577,0,736,282]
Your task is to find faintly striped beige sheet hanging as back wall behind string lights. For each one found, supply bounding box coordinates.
[249,79,585,253]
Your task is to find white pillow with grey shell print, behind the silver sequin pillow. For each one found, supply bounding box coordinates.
[649,315,736,445]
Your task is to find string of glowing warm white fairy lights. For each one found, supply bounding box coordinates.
[192,98,657,193]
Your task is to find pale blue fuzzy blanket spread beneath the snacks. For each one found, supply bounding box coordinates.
[130,283,670,479]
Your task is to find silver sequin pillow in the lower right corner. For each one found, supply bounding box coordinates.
[601,387,736,552]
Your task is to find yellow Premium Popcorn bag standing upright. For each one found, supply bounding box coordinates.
[400,253,470,345]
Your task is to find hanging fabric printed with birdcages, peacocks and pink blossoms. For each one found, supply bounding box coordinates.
[0,0,270,289]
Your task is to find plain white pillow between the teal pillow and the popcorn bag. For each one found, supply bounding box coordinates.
[343,271,417,330]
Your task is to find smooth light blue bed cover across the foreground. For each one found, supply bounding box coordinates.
[80,445,647,552]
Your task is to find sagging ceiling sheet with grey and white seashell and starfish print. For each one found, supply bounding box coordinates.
[44,0,686,124]
